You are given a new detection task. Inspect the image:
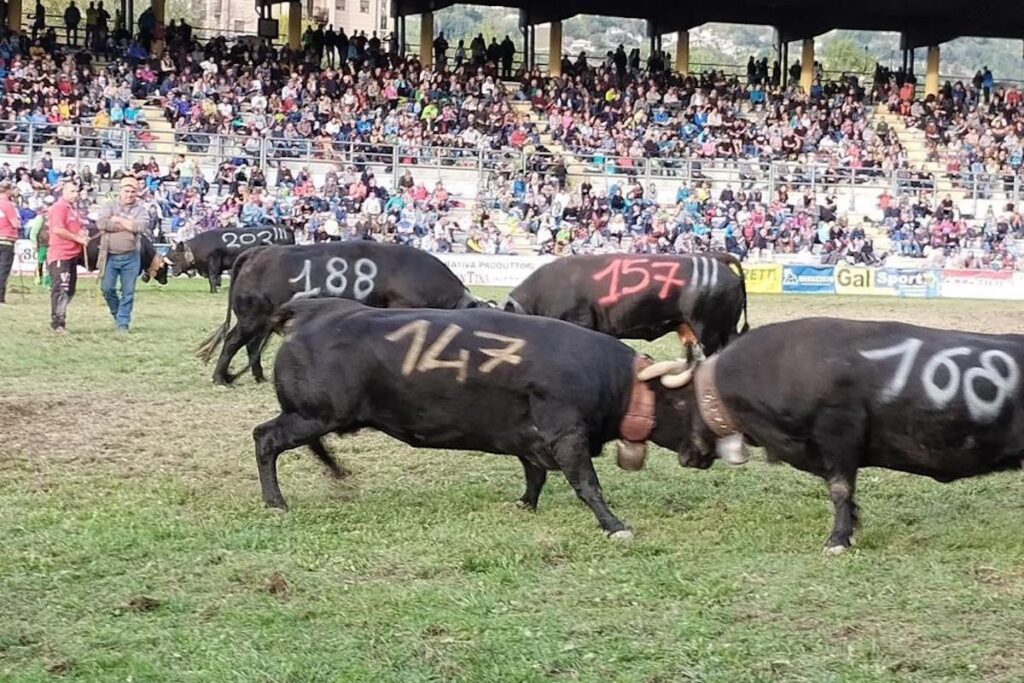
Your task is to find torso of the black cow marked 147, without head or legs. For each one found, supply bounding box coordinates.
[274,301,635,444]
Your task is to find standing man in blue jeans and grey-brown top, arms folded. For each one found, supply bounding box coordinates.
[96,176,150,333]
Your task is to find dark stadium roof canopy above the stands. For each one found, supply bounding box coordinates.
[392,0,1024,48]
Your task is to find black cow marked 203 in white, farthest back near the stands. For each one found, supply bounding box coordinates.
[170,226,295,294]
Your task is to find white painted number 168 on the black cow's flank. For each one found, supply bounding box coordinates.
[860,337,1020,423]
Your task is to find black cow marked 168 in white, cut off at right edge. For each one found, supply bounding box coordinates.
[667,317,1024,554]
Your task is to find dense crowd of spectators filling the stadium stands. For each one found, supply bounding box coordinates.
[0,8,1024,268]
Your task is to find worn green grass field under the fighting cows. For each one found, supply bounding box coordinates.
[0,279,1024,683]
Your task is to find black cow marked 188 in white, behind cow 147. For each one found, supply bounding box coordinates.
[197,241,489,384]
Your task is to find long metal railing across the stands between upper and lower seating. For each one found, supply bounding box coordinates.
[0,121,1024,214]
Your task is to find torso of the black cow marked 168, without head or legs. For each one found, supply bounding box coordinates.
[716,317,1024,479]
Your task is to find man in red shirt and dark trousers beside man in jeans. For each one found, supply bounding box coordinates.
[46,182,89,334]
